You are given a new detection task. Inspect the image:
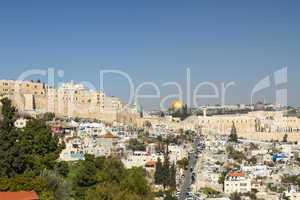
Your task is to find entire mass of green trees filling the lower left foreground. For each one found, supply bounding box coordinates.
[0,99,153,200]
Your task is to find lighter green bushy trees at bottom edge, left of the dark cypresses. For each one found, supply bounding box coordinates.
[74,155,153,200]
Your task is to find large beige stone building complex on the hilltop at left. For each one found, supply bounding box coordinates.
[0,80,122,122]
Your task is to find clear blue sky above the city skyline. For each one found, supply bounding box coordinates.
[0,0,300,107]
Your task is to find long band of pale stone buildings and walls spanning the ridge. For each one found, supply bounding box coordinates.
[0,80,300,141]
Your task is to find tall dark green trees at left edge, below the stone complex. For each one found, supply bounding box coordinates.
[0,98,63,178]
